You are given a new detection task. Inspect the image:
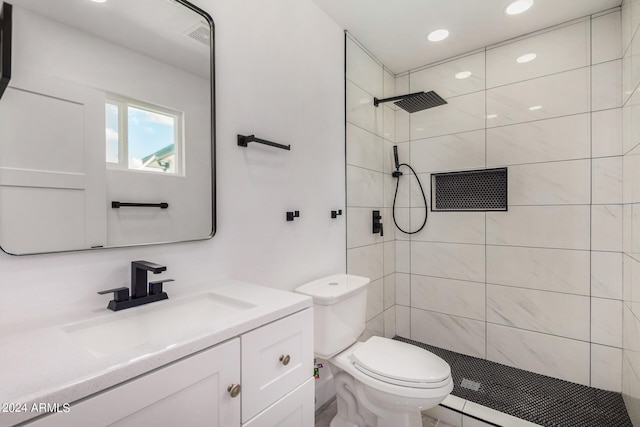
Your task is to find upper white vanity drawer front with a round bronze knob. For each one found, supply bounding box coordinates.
[240,308,313,422]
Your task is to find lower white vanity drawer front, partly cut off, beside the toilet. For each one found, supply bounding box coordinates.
[242,378,315,427]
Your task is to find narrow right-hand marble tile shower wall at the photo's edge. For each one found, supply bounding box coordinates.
[624,0,640,425]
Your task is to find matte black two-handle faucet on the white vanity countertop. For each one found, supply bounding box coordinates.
[98,260,173,311]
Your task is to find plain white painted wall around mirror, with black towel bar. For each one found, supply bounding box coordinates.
[0,0,345,333]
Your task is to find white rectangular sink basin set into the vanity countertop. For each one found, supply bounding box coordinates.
[63,293,255,357]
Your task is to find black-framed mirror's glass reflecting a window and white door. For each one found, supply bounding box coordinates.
[0,0,215,255]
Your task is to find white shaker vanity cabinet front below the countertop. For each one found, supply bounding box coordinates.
[23,308,314,427]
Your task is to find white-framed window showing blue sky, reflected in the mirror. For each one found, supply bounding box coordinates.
[105,99,182,175]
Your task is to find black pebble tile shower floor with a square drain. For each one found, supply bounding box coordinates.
[394,337,632,427]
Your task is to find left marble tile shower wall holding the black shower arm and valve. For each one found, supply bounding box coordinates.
[346,35,396,338]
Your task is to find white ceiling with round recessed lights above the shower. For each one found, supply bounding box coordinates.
[314,0,622,74]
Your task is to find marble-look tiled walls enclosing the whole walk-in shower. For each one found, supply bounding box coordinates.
[346,1,640,422]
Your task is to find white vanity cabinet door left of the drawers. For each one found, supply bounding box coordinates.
[25,338,240,427]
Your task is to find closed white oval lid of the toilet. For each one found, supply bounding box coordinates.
[353,337,451,388]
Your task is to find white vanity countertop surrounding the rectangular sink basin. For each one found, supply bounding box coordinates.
[0,280,312,426]
